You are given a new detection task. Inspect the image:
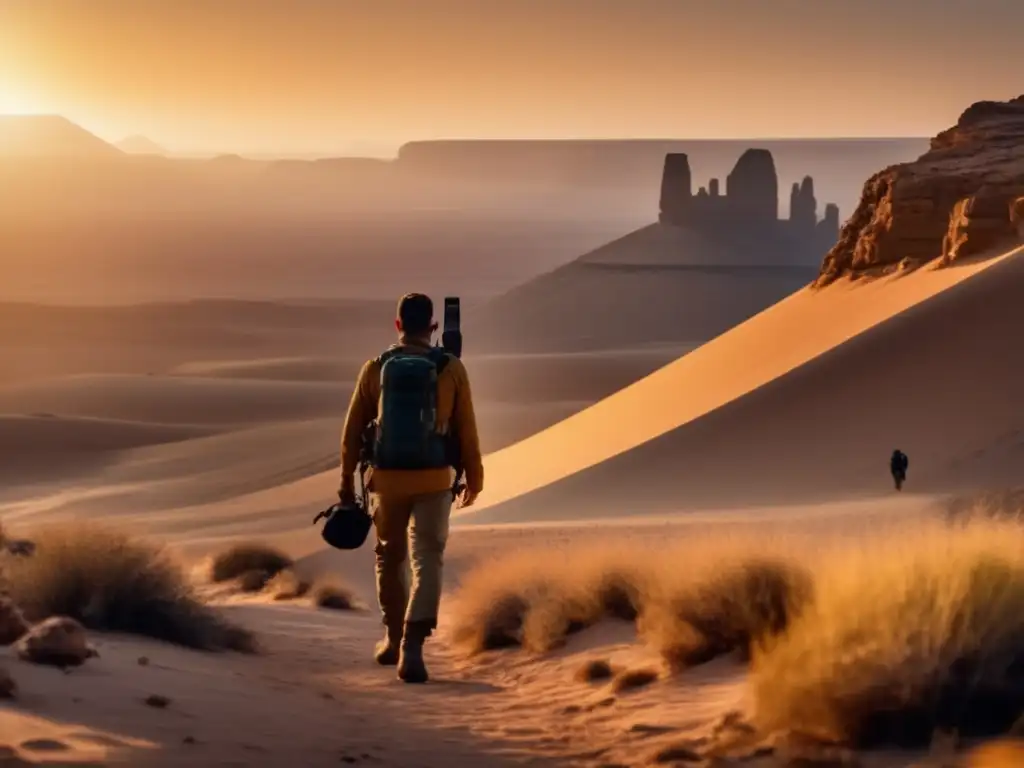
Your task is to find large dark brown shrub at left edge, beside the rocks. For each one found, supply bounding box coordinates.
[4,523,255,651]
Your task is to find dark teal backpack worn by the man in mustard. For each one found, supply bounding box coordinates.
[372,347,452,469]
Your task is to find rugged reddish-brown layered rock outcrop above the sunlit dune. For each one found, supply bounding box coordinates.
[817,96,1024,286]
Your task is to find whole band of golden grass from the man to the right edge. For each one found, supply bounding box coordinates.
[453,520,1024,748]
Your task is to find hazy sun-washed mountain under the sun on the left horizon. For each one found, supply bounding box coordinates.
[0,115,122,158]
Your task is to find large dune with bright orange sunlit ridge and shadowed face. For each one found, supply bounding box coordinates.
[467,250,1024,520]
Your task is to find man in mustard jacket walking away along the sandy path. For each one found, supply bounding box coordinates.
[339,293,483,683]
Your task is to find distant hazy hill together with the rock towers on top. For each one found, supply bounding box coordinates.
[472,148,839,352]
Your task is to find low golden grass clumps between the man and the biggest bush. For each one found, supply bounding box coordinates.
[454,540,813,669]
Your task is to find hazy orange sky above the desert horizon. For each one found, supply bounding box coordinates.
[0,0,1024,153]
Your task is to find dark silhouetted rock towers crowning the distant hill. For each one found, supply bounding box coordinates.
[658,148,839,261]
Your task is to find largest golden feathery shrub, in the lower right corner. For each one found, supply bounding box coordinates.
[753,522,1024,746]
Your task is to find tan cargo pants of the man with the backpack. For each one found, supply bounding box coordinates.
[371,490,453,630]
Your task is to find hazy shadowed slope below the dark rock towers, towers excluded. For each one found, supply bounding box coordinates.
[467,224,817,351]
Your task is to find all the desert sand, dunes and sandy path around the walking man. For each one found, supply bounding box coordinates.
[0,237,1024,766]
